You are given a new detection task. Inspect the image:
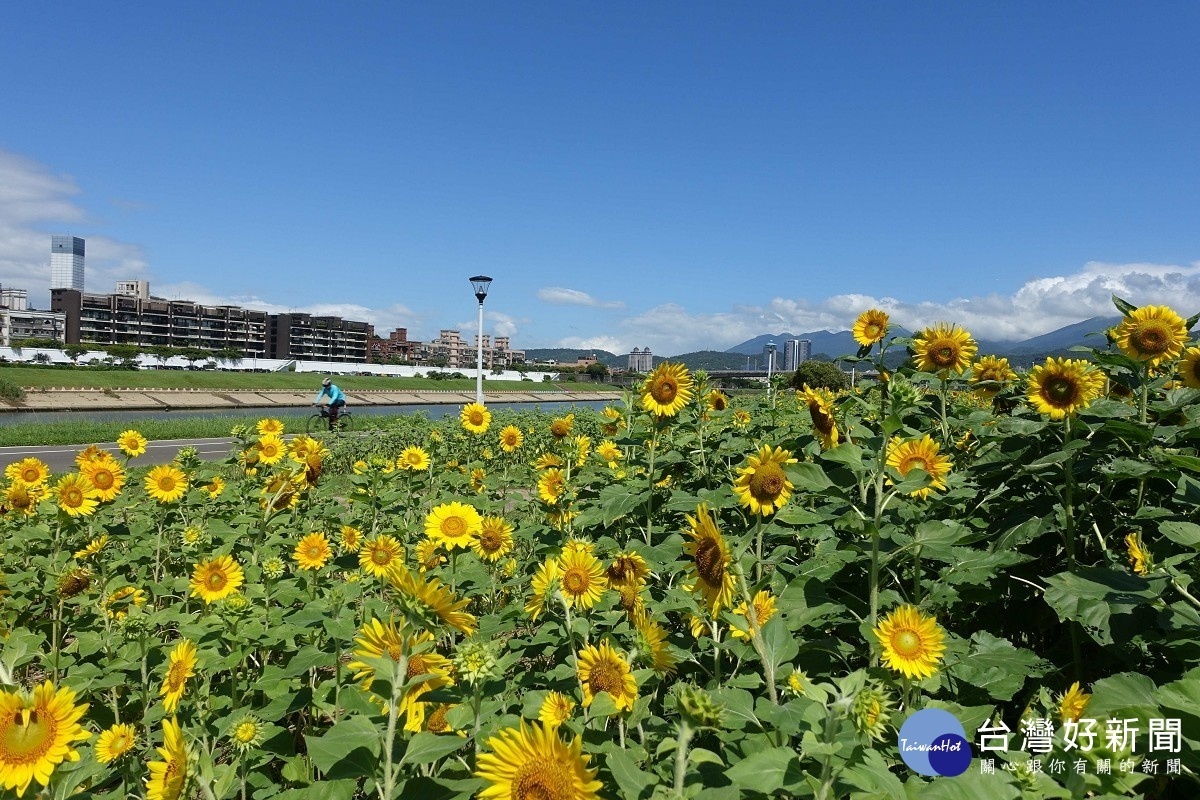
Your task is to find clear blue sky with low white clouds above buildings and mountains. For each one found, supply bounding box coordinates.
[0,2,1200,355]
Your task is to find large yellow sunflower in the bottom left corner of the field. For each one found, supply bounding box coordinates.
[0,681,91,796]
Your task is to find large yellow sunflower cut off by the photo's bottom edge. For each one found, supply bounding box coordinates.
[475,720,602,800]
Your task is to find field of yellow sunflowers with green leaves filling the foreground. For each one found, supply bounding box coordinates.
[0,300,1200,800]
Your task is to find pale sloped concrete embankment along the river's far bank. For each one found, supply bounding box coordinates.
[0,389,618,413]
